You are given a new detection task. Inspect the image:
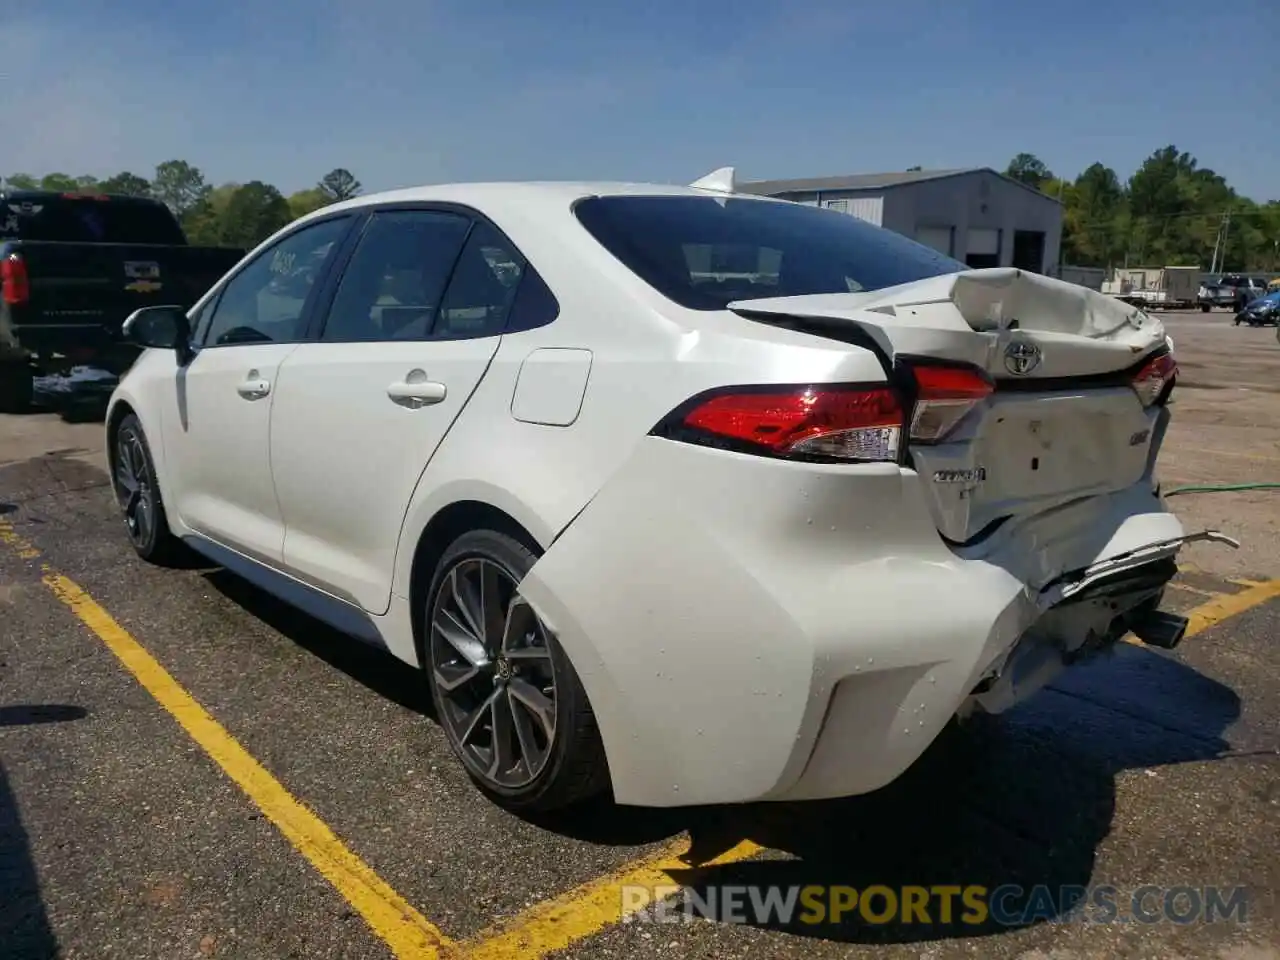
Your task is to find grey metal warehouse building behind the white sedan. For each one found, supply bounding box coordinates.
[737,168,1062,273]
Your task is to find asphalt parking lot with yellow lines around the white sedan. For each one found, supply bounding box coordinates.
[0,314,1280,960]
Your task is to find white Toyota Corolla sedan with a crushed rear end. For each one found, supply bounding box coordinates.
[106,172,1216,809]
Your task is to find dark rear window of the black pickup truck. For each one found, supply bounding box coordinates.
[0,196,187,244]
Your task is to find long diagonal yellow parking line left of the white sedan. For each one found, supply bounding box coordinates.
[0,521,449,960]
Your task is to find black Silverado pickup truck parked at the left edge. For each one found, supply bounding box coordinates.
[0,189,244,411]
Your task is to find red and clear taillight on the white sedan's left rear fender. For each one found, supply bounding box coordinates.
[677,387,902,461]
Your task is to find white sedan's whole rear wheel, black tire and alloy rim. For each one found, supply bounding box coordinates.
[422,530,608,810]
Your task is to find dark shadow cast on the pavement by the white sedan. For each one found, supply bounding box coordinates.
[205,571,1240,943]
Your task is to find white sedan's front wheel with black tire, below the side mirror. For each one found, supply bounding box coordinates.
[109,413,183,567]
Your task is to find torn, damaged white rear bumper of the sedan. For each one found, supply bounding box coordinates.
[521,438,1228,806]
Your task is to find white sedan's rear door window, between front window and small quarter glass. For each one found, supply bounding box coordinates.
[320,210,471,343]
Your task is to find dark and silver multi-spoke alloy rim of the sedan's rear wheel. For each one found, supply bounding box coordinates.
[429,557,557,792]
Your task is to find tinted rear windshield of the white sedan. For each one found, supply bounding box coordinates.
[575,196,966,310]
